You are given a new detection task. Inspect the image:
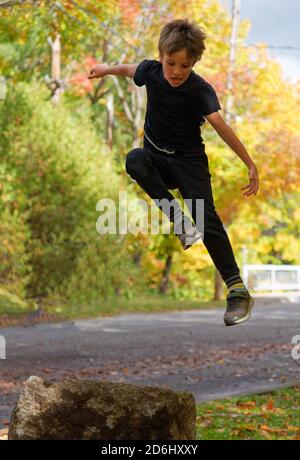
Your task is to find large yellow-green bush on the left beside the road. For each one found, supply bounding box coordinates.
[0,82,140,302]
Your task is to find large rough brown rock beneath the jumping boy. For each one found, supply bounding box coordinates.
[8,376,196,440]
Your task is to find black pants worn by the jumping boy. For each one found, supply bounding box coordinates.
[126,137,242,286]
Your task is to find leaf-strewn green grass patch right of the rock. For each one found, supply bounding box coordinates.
[196,386,300,440]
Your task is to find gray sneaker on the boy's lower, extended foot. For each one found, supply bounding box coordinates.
[224,288,254,326]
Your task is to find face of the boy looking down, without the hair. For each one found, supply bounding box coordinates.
[159,48,195,87]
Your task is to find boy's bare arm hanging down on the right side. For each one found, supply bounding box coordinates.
[204,112,259,196]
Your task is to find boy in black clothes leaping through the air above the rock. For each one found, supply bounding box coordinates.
[88,19,258,326]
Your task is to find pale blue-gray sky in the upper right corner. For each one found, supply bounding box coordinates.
[219,0,300,82]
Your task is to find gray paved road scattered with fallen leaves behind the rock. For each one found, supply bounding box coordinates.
[0,295,300,428]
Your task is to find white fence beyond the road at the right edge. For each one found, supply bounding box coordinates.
[243,264,300,291]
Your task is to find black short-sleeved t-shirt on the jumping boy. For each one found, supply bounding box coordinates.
[133,59,221,153]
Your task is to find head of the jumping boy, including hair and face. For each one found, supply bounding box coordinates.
[158,19,206,87]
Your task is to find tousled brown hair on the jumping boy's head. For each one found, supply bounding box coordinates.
[158,18,206,65]
